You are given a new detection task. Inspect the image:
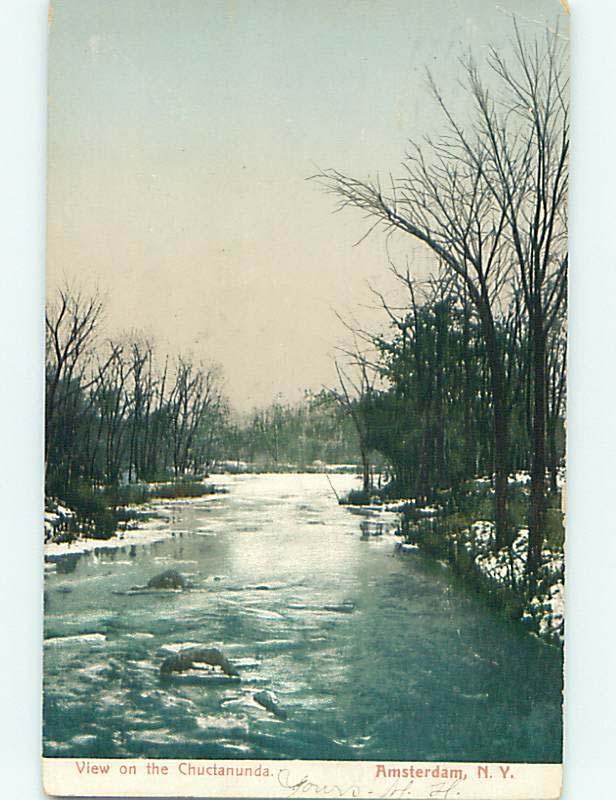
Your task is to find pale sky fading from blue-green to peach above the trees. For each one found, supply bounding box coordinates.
[48,0,566,409]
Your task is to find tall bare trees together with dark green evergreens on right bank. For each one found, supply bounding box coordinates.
[315,25,569,573]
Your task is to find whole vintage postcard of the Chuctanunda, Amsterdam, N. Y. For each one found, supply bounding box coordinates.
[42,0,569,800]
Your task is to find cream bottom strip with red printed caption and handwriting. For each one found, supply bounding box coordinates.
[42,758,562,800]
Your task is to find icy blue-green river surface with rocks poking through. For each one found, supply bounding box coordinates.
[44,475,561,762]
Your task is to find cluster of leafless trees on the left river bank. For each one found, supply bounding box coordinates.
[45,289,228,497]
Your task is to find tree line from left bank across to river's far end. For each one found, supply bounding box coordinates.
[45,288,366,498]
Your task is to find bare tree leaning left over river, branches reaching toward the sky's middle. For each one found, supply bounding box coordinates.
[316,95,512,545]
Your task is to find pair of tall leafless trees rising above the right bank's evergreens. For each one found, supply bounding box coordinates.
[317,25,569,573]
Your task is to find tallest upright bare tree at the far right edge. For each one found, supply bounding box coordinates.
[460,24,569,574]
